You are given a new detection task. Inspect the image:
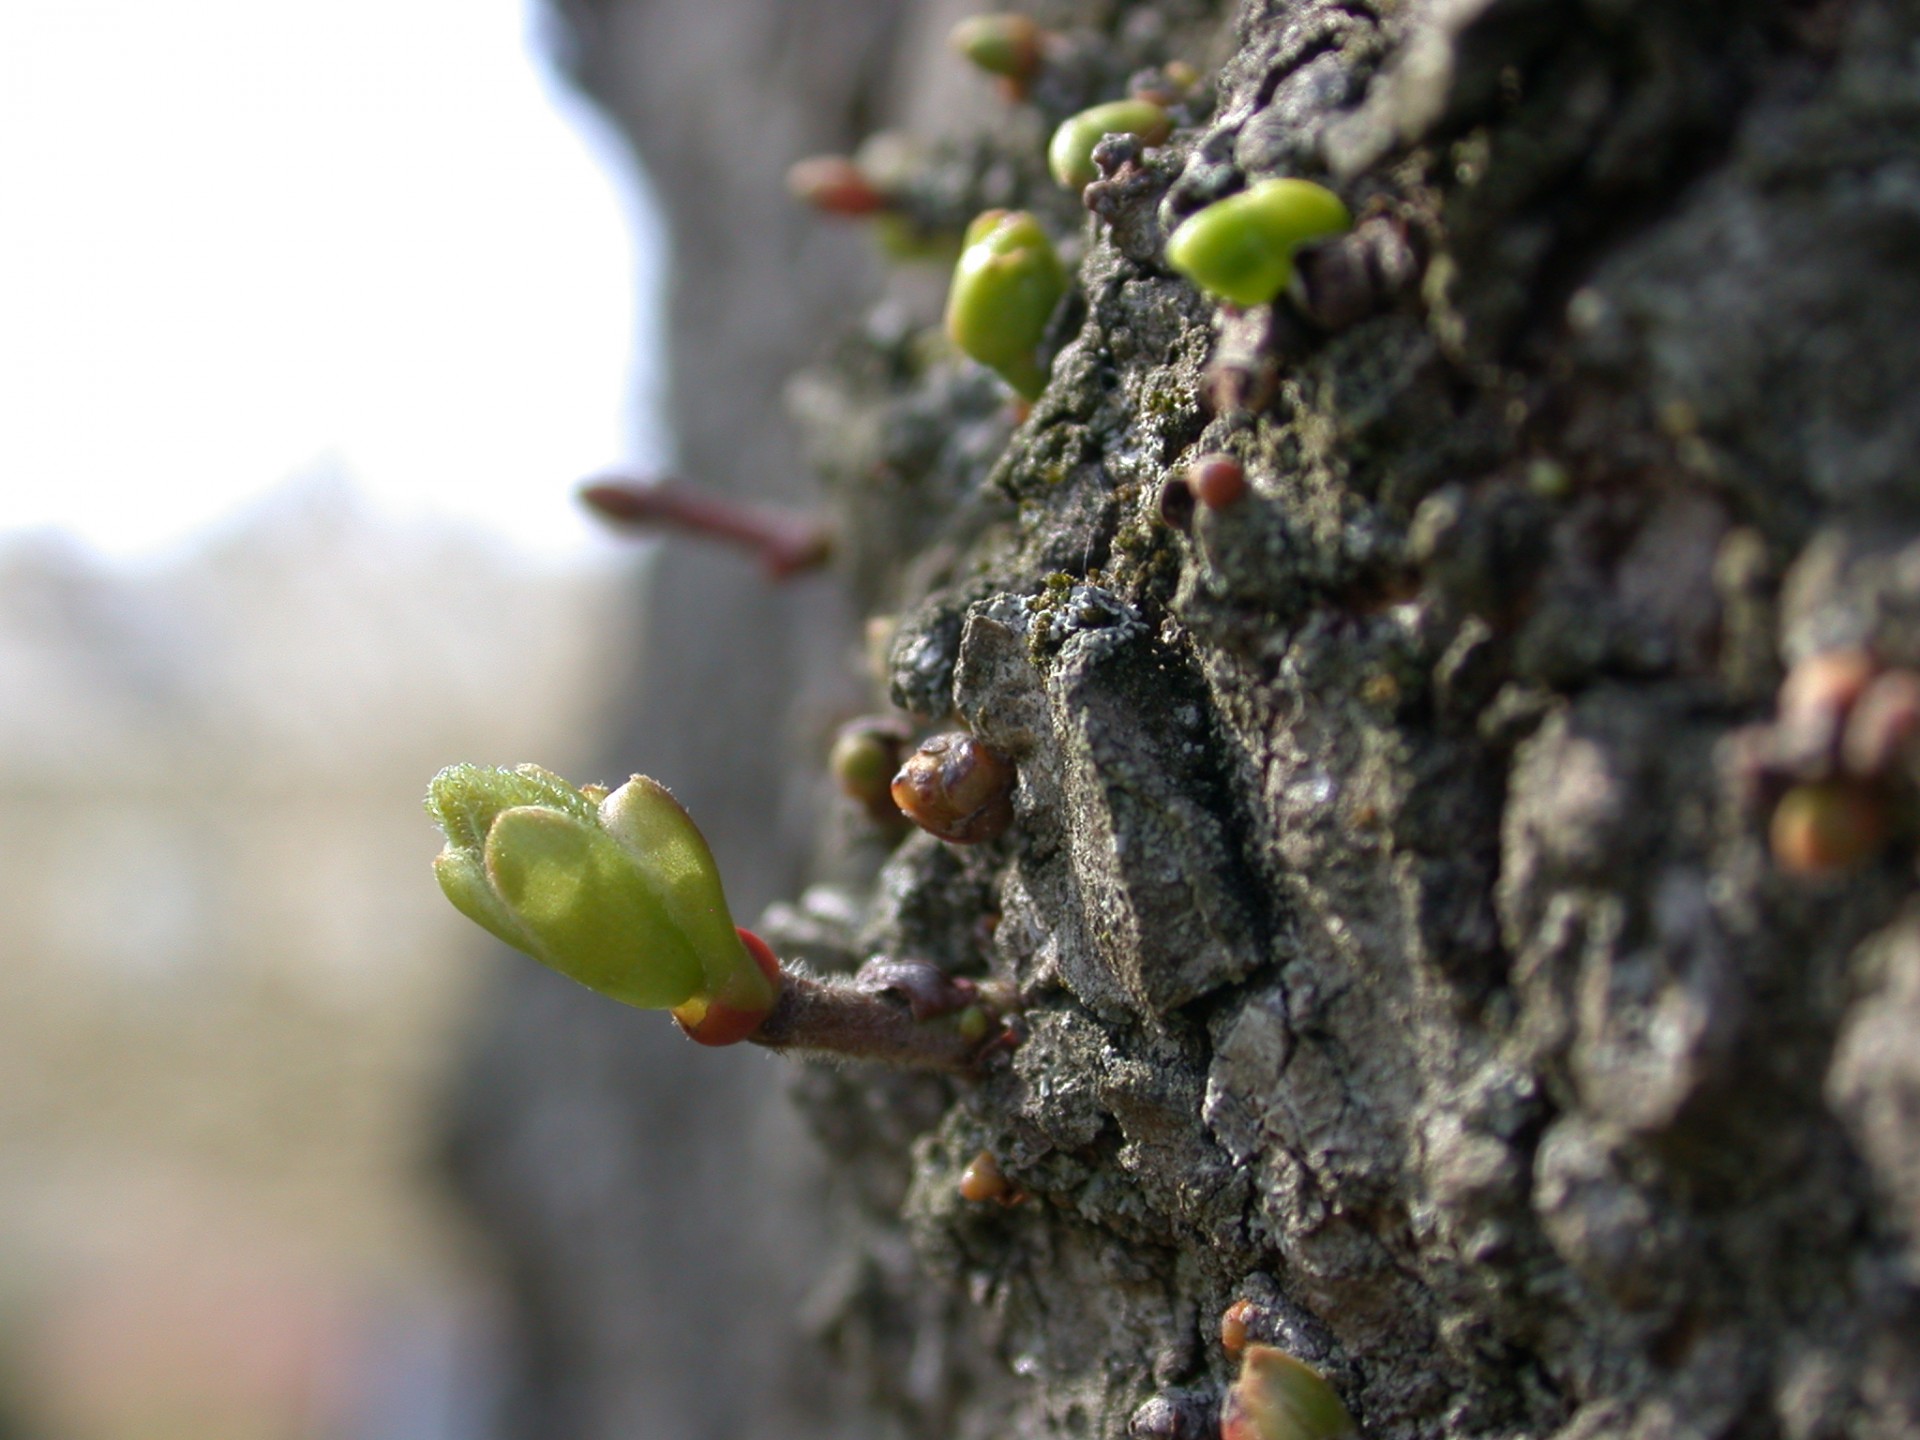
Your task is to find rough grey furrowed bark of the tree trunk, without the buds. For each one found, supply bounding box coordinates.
[441,0,1920,1440]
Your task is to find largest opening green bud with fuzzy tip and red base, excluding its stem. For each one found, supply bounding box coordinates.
[426,764,778,1039]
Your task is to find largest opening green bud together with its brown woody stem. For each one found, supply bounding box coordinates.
[426,764,1004,1071]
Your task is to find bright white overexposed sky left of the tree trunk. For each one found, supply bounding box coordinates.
[0,0,662,555]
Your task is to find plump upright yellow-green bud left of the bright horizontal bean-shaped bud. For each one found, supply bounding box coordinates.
[947,209,1068,399]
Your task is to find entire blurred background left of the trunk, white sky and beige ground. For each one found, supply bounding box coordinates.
[0,0,668,1440]
